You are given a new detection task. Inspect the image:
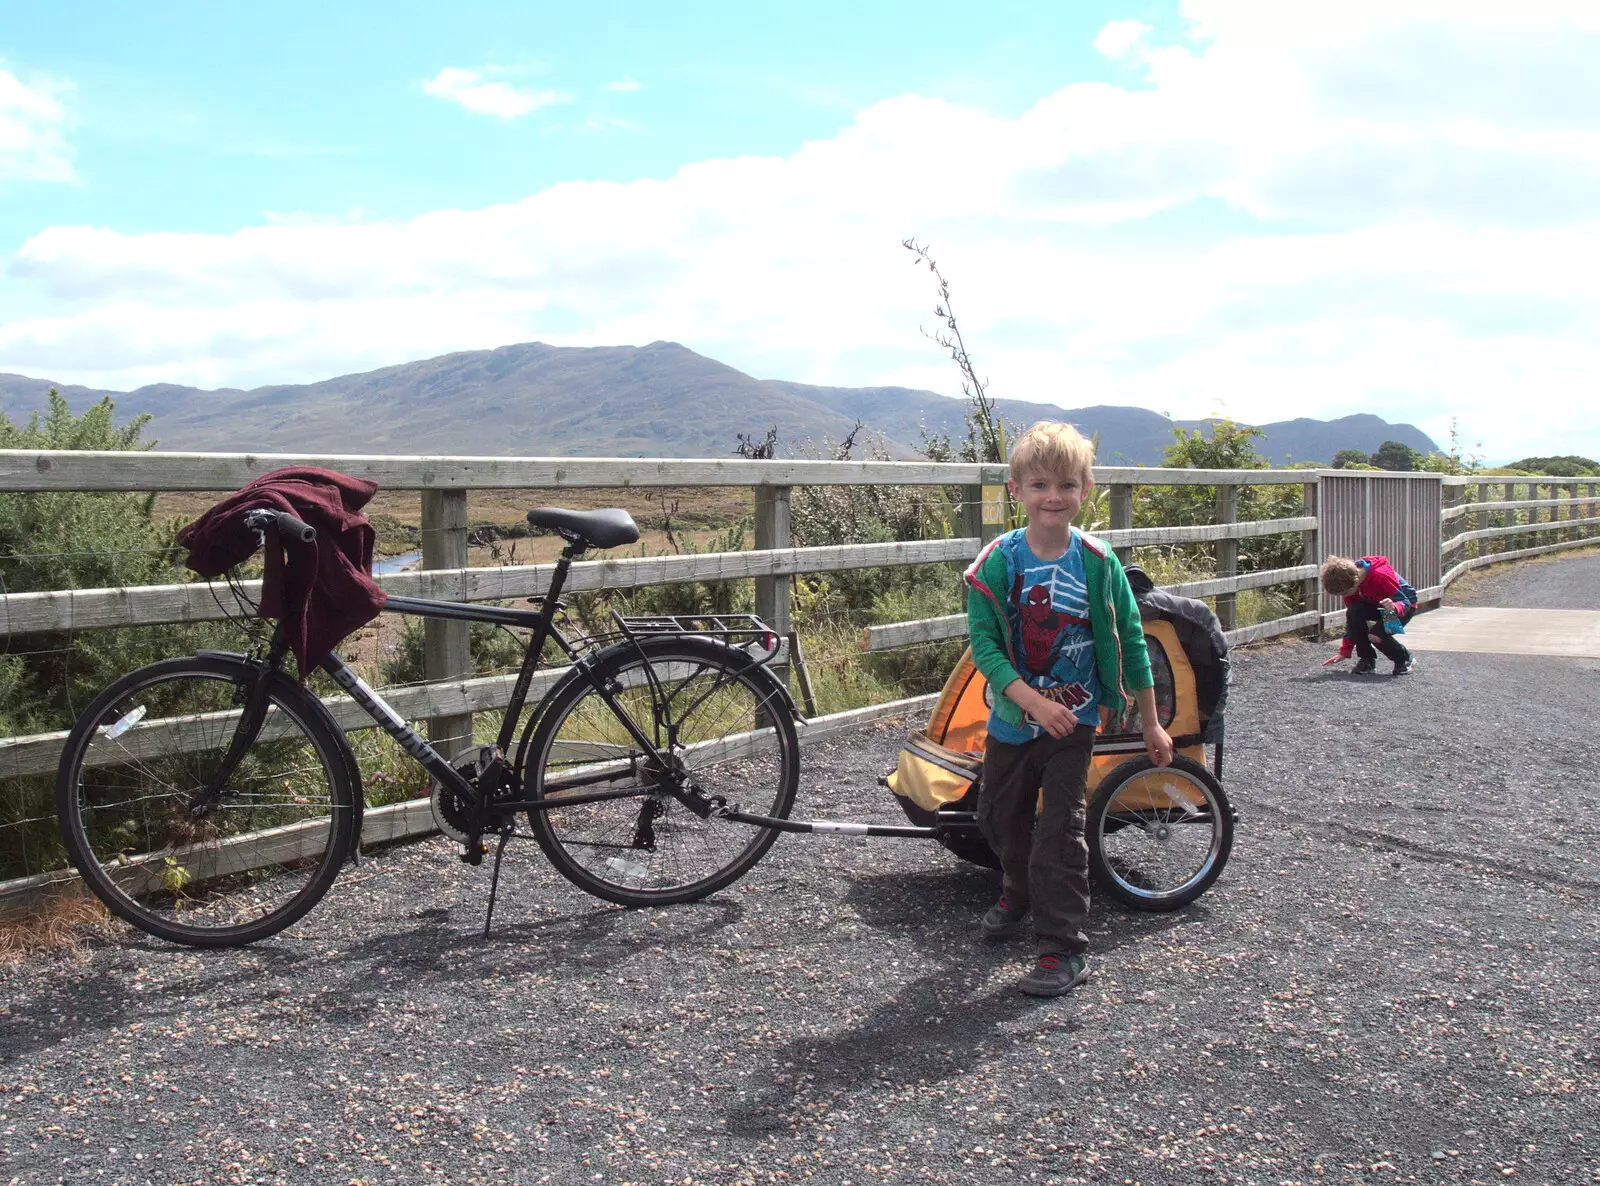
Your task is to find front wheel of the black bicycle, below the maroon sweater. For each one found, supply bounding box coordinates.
[56,656,357,948]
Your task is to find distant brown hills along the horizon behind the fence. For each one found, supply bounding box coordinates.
[0,343,1438,466]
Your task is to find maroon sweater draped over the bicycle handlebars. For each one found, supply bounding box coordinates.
[178,466,386,683]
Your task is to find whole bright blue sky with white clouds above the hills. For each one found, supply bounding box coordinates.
[0,0,1600,461]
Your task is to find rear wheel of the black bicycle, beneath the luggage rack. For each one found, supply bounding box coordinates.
[518,637,800,906]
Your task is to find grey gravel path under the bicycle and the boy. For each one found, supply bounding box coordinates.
[0,554,1600,1186]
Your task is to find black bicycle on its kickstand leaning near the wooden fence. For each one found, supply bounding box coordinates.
[56,507,800,948]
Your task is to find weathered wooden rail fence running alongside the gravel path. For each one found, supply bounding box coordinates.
[0,450,1600,901]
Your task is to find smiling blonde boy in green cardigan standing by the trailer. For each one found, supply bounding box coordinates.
[966,421,1173,997]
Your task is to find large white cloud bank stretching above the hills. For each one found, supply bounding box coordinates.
[0,0,1600,456]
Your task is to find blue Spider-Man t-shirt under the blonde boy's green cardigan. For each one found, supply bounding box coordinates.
[989,531,1099,746]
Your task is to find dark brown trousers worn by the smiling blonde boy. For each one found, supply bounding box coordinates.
[978,725,1094,956]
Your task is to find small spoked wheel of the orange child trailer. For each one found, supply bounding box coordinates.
[1085,755,1234,912]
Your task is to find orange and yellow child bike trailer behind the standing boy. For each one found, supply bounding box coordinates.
[880,565,1235,911]
